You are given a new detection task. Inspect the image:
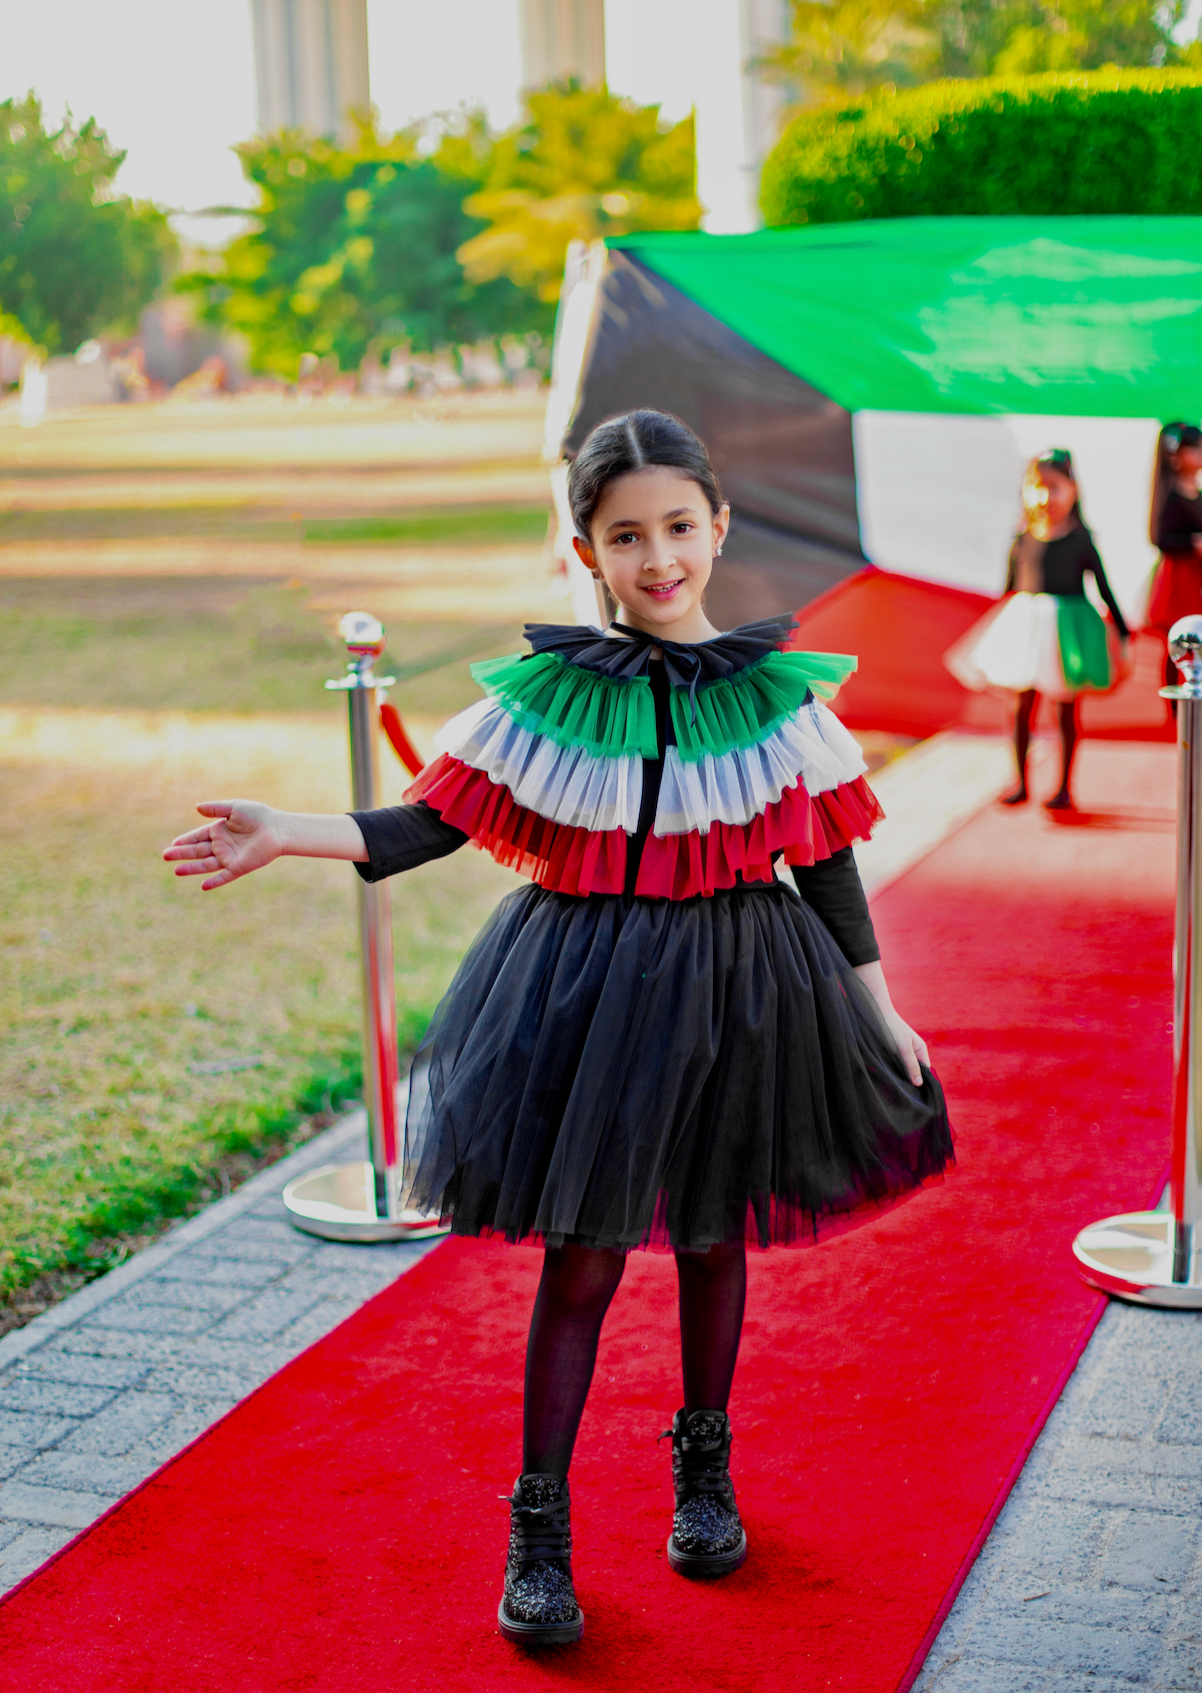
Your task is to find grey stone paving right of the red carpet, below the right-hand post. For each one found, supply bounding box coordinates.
[916,1304,1202,1693]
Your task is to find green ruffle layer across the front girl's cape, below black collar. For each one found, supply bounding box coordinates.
[472,639,857,762]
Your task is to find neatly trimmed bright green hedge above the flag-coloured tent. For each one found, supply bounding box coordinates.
[760,69,1202,223]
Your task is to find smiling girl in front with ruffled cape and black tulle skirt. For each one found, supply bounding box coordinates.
[164,411,951,1644]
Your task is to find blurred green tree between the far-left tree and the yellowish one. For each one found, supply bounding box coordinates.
[179,115,549,378]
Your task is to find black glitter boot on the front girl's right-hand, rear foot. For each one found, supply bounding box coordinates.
[664,1410,747,1578]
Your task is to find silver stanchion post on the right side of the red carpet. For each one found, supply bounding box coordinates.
[1073,618,1202,1310]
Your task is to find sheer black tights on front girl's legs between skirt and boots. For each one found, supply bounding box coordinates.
[521,1241,747,1476]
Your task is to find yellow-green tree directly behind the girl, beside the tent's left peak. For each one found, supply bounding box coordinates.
[459,83,701,303]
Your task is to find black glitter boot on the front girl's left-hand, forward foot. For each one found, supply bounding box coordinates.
[496,1475,584,1646]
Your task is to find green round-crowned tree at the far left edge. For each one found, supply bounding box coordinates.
[0,93,176,352]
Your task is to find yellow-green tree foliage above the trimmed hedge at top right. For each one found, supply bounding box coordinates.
[762,0,1188,105]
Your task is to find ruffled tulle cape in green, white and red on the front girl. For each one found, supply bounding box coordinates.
[405,618,882,899]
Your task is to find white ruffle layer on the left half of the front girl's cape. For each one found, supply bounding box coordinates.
[435,699,643,835]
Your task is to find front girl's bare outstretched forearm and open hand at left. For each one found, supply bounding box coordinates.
[163,799,367,891]
